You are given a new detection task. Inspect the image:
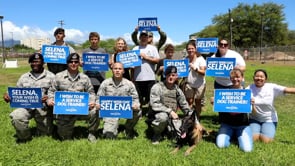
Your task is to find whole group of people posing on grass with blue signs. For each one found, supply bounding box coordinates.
[4,27,295,152]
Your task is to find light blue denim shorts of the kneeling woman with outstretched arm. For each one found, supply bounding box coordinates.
[250,119,277,139]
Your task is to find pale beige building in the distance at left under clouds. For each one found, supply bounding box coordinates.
[20,38,51,50]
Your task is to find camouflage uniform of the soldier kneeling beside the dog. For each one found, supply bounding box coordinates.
[149,81,191,137]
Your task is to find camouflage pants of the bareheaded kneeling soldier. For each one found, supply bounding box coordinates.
[102,111,140,135]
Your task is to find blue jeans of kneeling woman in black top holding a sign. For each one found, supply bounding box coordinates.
[216,123,253,152]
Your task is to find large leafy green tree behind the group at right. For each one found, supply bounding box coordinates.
[196,2,288,47]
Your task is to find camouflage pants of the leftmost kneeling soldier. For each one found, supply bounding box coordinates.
[9,108,53,140]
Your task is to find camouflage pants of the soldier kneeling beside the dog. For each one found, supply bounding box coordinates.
[152,112,181,135]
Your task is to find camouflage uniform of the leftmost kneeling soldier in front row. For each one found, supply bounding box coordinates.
[10,70,54,140]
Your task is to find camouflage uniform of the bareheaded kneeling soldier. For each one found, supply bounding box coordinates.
[97,78,140,137]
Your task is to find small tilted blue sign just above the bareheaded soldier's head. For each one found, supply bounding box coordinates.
[116,50,142,68]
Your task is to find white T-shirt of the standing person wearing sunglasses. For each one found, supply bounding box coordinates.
[212,49,246,86]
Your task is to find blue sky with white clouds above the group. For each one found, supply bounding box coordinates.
[0,0,295,45]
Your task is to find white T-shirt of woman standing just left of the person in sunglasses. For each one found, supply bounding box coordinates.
[187,55,206,88]
